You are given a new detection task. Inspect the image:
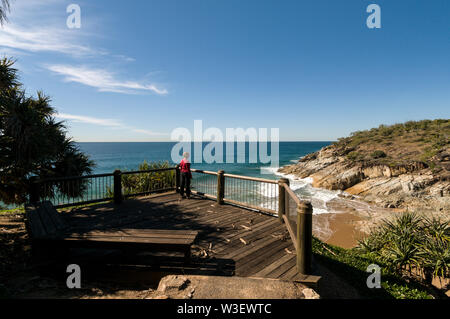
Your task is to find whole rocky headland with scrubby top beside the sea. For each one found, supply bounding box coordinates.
[279,119,450,240]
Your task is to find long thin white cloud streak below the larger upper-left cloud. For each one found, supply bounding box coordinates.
[46,65,168,95]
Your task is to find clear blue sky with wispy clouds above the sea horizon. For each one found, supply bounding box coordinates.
[0,0,450,141]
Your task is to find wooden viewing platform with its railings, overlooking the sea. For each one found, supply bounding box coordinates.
[29,167,320,286]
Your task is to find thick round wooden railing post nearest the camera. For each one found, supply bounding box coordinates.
[297,202,312,275]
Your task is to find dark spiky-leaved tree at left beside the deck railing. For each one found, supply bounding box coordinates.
[0,58,93,204]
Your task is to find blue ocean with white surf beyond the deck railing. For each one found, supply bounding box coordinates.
[78,142,338,214]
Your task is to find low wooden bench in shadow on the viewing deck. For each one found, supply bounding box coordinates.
[26,201,198,262]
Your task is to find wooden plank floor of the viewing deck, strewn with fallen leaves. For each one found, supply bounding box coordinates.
[53,192,318,285]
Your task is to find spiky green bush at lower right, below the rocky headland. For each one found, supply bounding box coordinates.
[358,213,450,281]
